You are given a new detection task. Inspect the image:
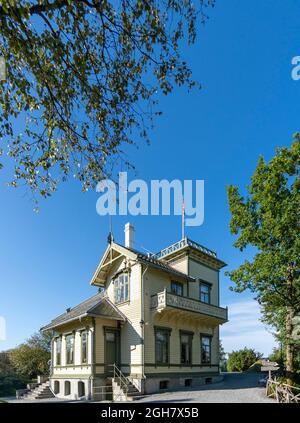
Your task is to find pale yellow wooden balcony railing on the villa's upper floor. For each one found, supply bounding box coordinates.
[151,290,228,321]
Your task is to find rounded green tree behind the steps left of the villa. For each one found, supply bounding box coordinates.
[9,334,51,378]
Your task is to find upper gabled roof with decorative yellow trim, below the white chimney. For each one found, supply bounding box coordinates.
[90,242,195,286]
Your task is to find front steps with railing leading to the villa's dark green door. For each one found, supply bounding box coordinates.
[112,364,141,401]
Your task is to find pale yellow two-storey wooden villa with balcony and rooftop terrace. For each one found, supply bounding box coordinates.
[43,224,227,399]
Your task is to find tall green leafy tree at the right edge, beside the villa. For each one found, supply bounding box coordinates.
[228,134,300,382]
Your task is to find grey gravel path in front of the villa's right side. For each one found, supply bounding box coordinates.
[139,373,275,403]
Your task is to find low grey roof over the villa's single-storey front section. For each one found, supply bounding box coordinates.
[41,293,126,331]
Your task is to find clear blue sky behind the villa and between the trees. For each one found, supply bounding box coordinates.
[0,0,300,354]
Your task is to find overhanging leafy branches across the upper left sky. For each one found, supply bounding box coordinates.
[0,0,215,196]
